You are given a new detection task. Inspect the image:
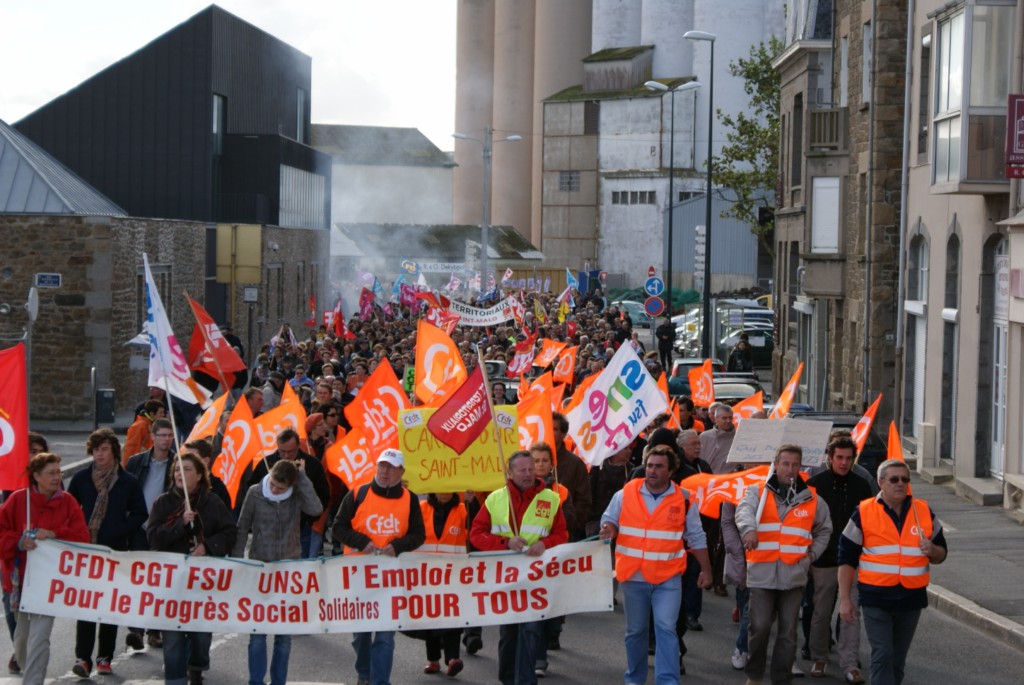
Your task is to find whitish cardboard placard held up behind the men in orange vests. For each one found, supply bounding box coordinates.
[726,419,833,467]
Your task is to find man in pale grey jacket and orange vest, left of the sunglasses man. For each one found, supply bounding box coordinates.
[736,444,831,685]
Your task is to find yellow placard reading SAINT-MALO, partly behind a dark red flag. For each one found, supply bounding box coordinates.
[398,404,519,495]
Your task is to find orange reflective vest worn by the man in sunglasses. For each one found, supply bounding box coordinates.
[857,499,932,590]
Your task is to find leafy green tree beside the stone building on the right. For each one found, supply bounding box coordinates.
[712,37,783,258]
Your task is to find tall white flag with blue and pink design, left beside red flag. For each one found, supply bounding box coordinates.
[142,253,210,406]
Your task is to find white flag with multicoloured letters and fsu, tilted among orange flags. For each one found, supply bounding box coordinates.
[565,345,669,466]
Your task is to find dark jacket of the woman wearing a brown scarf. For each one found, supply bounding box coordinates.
[68,465,150,552]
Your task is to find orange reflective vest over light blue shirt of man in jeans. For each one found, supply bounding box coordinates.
[615,478,686,585]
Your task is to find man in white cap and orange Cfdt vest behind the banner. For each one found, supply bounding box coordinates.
[332,449,426,685]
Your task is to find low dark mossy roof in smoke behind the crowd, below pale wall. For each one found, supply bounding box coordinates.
[331,223,544,261]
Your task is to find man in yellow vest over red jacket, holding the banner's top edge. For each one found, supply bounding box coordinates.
[469,451,568,685]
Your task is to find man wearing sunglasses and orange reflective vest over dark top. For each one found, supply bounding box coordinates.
[839,459,947,685]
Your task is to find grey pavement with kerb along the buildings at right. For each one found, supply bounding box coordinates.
[912,473,1024,651]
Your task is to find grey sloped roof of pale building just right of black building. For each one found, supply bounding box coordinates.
[310,124,454,167]
